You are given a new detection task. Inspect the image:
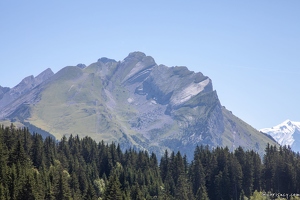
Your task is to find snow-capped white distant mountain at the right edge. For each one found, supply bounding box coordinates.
[260,120,300,152]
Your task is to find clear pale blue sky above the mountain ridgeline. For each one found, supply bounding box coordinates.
[0,0,300,129]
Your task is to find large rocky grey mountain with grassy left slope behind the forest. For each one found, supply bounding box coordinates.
[0,52,276,158]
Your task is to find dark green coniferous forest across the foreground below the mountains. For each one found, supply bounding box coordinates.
[0,125,300,200]
